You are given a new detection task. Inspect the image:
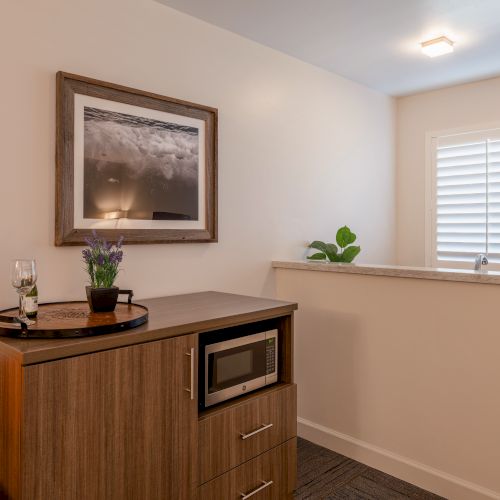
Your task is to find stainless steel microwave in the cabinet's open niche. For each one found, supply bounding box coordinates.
[200,329,279,408]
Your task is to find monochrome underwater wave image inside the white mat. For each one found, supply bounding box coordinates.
[83,106,199,220]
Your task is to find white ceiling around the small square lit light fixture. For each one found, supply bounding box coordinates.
[158,0,500,96]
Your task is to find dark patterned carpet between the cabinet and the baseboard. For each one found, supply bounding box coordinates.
[295,438,443,500]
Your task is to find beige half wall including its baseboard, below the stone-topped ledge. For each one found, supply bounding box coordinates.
[275,269,500,500]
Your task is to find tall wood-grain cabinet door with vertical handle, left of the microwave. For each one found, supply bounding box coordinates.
[21,335,197,500]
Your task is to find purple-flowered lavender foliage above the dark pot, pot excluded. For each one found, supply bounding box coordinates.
[82,231,123,288]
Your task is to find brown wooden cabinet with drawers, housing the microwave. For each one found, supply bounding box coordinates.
[0,292,297,500]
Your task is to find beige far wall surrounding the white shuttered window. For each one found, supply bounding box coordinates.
[396,78,500,266]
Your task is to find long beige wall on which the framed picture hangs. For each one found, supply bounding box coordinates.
[0,0,394,306]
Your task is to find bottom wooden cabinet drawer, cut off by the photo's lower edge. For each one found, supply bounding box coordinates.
[198,438,297,500]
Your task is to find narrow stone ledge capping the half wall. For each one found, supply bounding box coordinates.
[272,260,500,285]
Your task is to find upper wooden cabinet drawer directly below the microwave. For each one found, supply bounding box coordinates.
[199,384,297,484]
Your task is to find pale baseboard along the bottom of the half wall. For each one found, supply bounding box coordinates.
[297,417,500,500]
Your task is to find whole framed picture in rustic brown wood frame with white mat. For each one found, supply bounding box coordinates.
[55,72,217,246]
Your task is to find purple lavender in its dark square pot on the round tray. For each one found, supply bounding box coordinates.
[82,231,123,312]
